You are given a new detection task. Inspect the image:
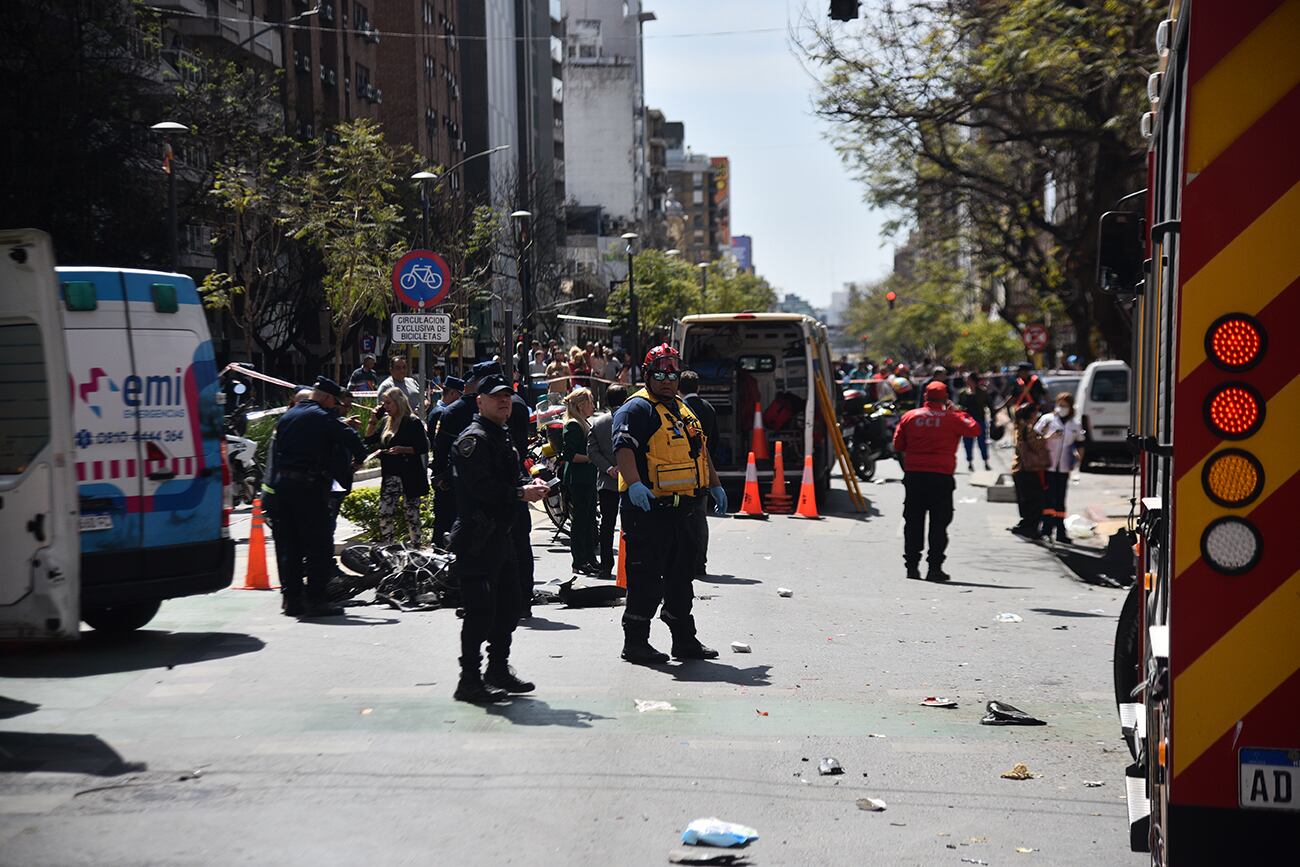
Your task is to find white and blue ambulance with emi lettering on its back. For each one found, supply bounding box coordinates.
[0,230,234,638]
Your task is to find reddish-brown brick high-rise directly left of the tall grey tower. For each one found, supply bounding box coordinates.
[372,0,467,181]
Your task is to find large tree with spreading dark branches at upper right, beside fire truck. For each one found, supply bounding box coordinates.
[803,0,1161,359]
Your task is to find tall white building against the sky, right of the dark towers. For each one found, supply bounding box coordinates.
[563,0,654,234]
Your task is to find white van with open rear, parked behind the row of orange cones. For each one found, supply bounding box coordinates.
[673,313,840,507]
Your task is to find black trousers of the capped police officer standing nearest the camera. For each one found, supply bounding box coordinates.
[451,520,519,671]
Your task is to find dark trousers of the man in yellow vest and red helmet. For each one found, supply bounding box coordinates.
[620,497,697,640]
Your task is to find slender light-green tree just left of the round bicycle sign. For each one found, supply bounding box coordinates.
[283,120,412,377]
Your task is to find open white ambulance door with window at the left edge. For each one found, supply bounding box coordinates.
[0,229,81,638]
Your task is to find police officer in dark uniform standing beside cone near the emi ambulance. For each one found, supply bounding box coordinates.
[268,377,365,617]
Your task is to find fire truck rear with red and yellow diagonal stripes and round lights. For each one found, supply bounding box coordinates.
[1100,0,1300,867]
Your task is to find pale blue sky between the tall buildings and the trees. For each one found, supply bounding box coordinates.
[645,0,893,307]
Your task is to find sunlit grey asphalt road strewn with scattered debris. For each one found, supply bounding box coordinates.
[0,452,1143,867]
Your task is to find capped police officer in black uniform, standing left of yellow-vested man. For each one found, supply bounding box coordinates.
[450,373,547,705]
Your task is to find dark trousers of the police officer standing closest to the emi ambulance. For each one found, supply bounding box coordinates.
[263,481,334,602]
